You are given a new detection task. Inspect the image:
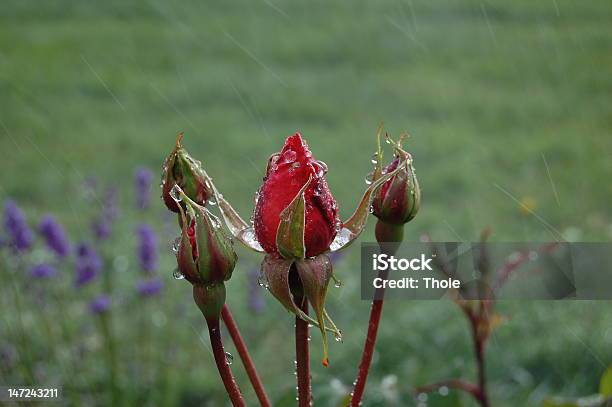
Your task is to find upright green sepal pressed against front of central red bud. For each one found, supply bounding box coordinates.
[276,176,312,259]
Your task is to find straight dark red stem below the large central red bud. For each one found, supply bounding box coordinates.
[295,296,312,407]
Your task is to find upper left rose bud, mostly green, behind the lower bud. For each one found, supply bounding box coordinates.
[162,133,212,213]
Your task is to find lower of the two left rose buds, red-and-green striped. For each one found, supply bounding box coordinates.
[171,187,237,285]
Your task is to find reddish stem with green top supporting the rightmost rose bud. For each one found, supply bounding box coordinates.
[351,220,404,407]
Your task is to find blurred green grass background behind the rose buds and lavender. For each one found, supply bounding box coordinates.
[0,0,612,406]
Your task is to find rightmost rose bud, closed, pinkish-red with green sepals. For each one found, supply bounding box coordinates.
[372,138,421,225]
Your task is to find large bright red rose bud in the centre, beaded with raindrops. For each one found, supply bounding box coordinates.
[254,133,340,258]
